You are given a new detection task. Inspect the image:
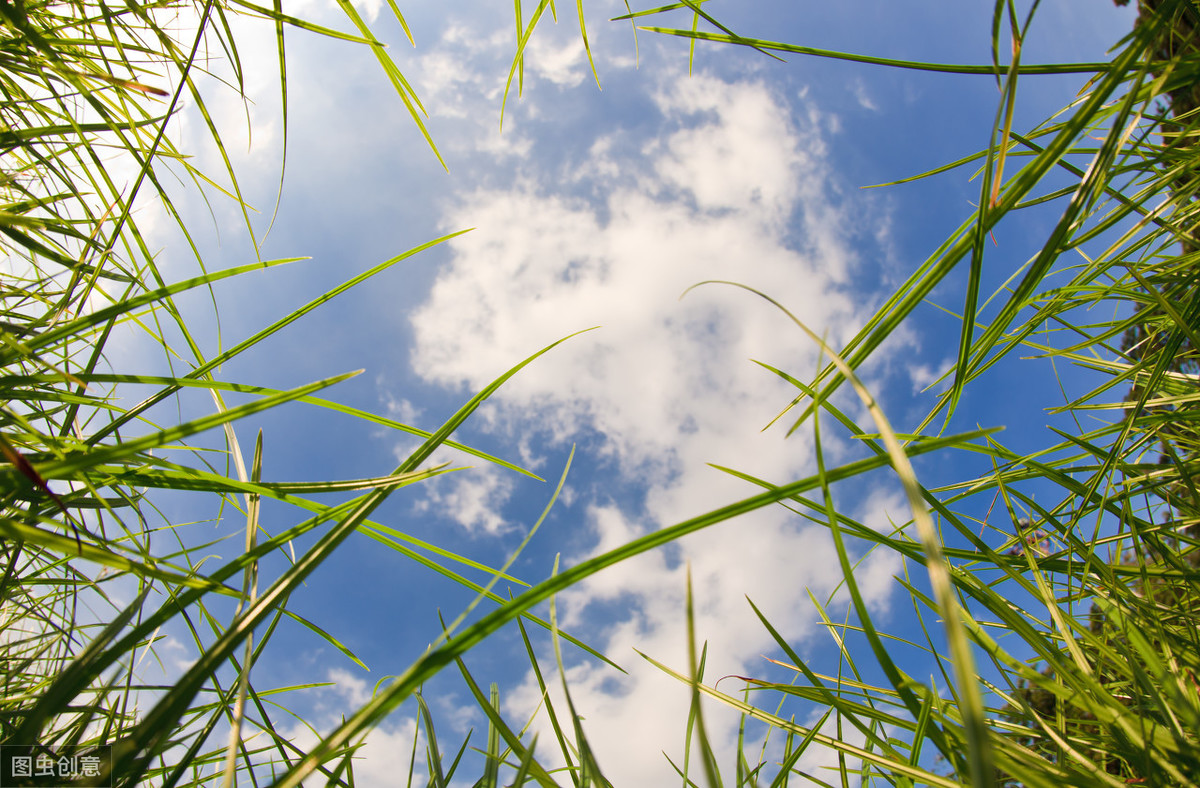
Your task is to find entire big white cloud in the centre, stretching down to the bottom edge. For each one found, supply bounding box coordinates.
[412,70,904,786]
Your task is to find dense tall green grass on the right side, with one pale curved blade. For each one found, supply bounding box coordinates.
[600,0,1200,786]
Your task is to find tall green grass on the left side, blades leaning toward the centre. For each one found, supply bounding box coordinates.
[0,0,597,786]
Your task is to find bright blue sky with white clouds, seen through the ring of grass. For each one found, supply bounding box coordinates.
[119,0,1132,786]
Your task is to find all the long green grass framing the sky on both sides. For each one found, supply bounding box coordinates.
[0,0,1200,787]
